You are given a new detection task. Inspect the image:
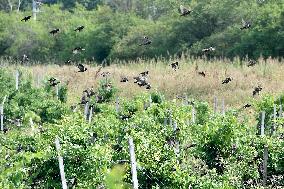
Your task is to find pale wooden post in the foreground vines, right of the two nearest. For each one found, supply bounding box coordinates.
[128,137,138,189]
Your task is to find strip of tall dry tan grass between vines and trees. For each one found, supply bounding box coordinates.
[5,58,284,106]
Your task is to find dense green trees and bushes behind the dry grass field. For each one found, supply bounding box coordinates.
[0,0,284,63]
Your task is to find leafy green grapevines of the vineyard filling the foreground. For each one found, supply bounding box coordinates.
[0,68,284,189]
